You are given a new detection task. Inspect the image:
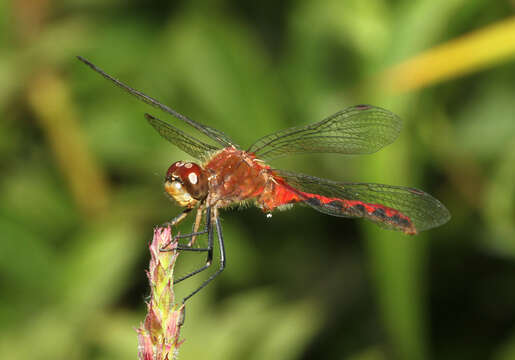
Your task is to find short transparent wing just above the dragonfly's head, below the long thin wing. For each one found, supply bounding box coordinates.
[145,114,219,160]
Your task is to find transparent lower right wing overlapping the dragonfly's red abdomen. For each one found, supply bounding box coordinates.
[274,170,451,232]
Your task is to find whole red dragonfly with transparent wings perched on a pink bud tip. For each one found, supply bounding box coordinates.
[78,56,450,303]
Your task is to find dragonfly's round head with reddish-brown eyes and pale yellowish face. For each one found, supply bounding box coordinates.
[165,161,208,208]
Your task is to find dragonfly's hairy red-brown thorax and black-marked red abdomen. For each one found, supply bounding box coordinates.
[204,148,417,234]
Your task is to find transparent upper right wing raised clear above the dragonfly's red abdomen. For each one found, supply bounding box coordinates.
[248,105,402,160]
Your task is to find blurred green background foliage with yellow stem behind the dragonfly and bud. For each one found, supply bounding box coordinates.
[0,0,515,360]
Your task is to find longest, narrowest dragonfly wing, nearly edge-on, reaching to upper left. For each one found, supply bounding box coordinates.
[77,56,238,148]
